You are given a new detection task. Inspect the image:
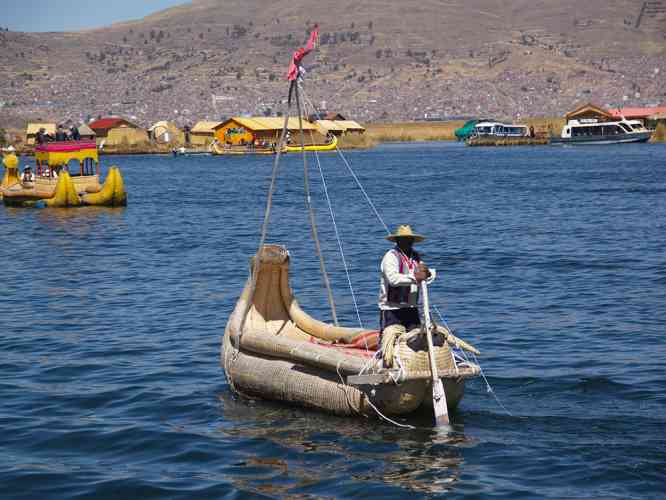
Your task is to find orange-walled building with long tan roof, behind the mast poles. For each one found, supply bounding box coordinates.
[214,116,322,146]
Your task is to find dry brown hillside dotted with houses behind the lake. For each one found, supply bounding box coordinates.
[0,0,666,124]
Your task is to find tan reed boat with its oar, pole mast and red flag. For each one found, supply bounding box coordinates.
[221,26,480,426]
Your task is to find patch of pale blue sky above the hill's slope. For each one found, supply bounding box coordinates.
[0,0,188,31]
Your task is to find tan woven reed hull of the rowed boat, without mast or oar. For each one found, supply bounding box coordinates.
[221,245,480,416]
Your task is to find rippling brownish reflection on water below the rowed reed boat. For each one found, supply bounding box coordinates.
[219,391,475,495]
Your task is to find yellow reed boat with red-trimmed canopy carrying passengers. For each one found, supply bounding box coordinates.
[0,141,127,207]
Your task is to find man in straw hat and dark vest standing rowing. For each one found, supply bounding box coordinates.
[379,225,434,366]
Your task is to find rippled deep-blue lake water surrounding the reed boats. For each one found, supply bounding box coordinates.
[0,143,666,499]
